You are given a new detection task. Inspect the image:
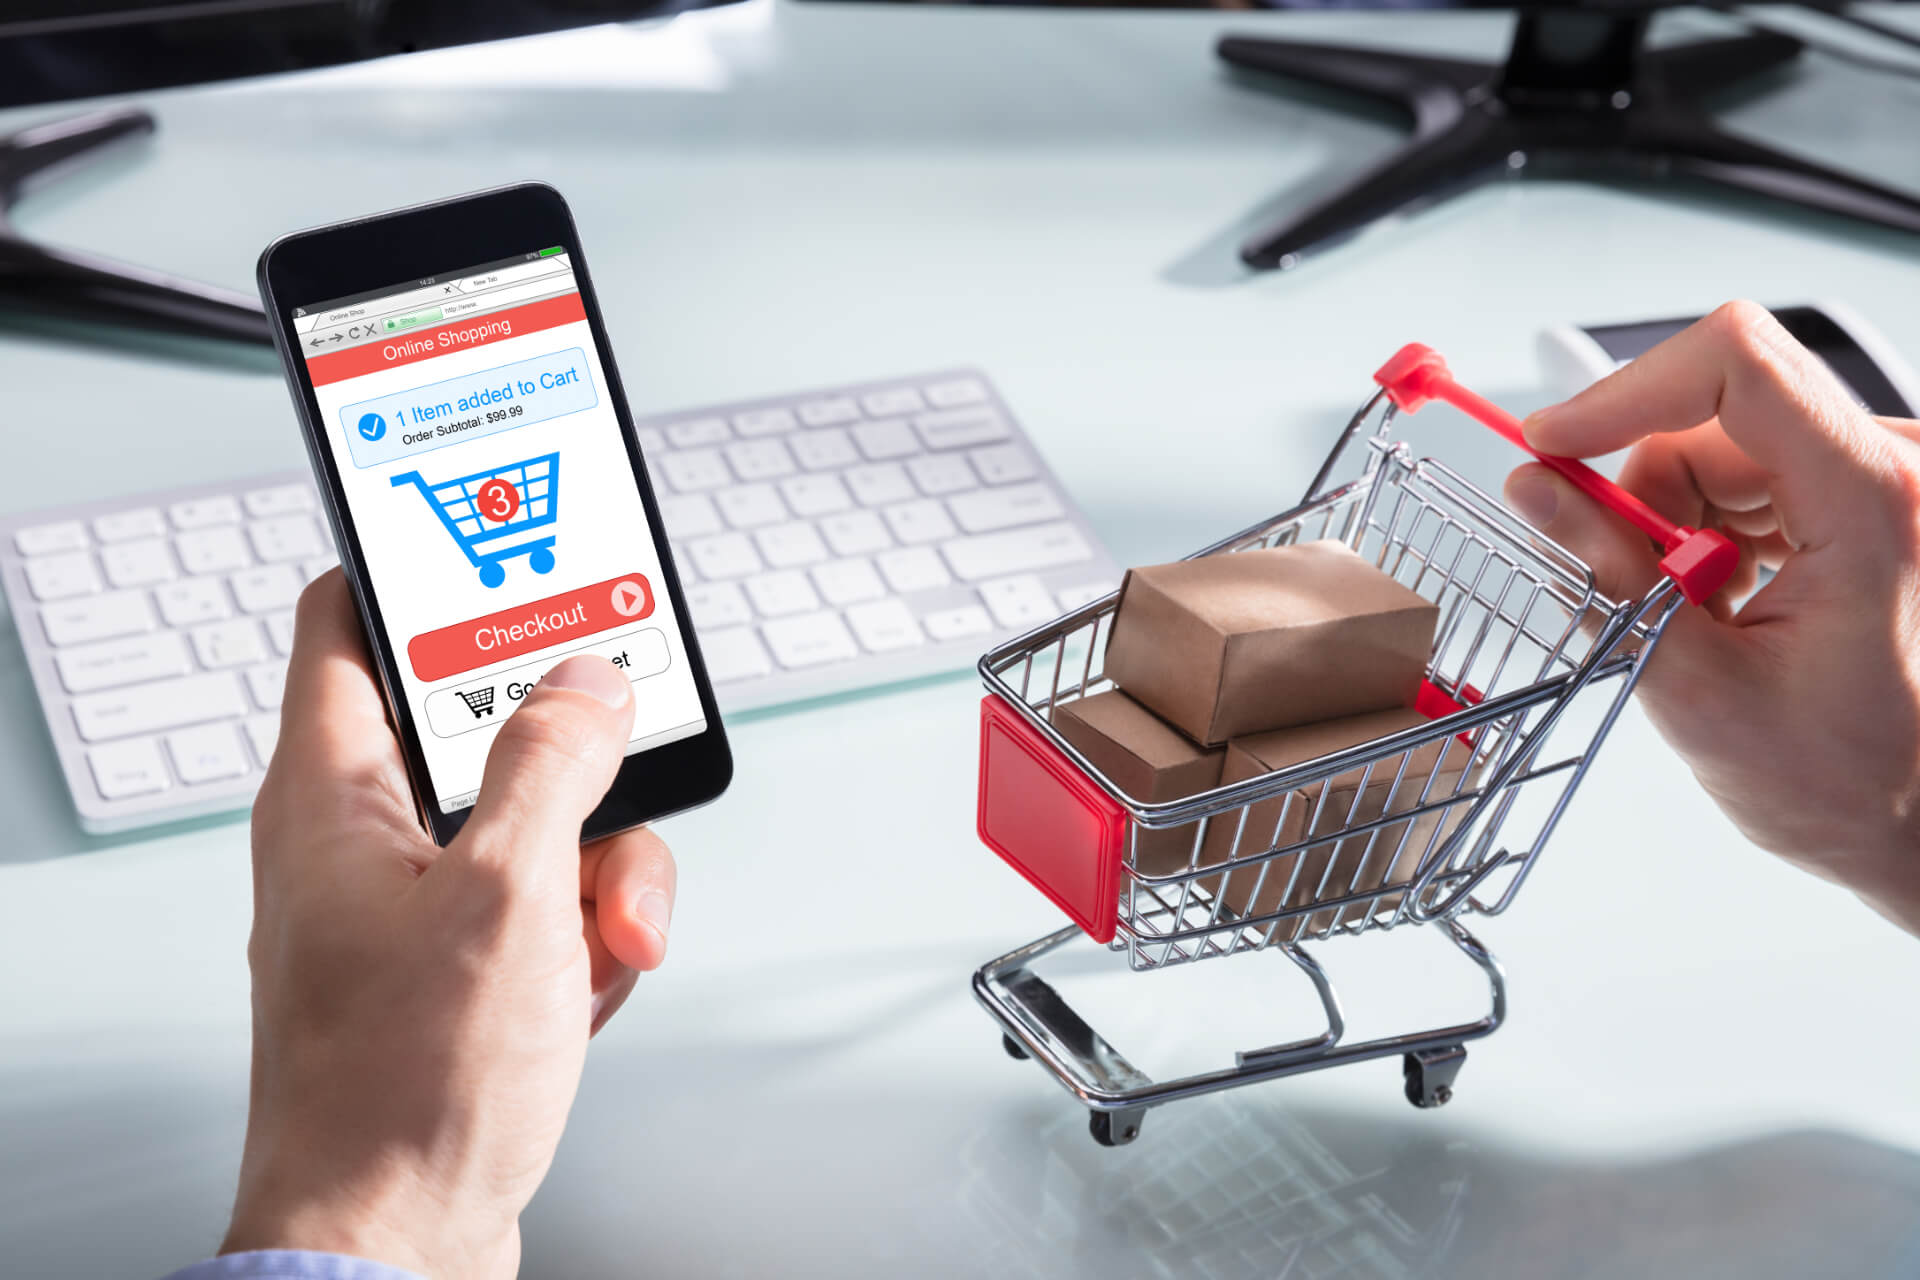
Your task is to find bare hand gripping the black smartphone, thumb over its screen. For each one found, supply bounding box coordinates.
[225,572,674,1278]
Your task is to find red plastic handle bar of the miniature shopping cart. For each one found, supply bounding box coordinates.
[1373,342,1740,604]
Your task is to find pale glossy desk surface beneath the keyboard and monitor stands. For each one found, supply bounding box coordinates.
[0,0,1920,1280]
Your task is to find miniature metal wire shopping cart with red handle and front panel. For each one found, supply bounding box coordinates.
[973,345,1740,1146]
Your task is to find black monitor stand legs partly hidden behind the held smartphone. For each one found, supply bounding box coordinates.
[0,107,273,345]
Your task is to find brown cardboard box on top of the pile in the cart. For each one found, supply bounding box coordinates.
[1106,541,1440,747]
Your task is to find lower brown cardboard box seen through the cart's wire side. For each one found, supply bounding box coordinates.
[1202,708,1473,936]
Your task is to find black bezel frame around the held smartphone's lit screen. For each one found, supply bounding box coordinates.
[257,182,733,844]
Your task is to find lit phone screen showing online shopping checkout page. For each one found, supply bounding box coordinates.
[288,248,707,814]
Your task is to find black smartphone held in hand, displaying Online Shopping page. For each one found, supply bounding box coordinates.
[259,184,733,844]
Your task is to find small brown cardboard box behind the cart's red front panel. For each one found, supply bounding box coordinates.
[1052,689,1227,875]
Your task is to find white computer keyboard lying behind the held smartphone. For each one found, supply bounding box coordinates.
[0,370,1119,831]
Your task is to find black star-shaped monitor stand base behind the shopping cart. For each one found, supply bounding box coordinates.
[1219,10,1920,269]
